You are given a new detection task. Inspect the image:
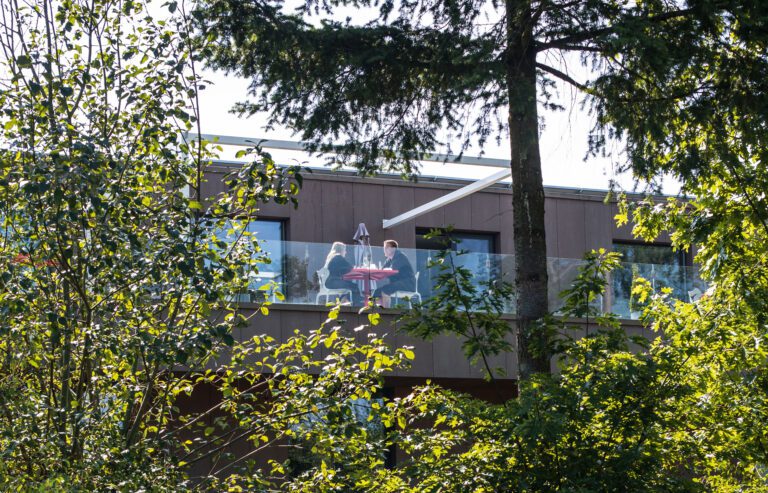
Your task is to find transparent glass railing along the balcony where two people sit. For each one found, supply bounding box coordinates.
[248,241,706,319]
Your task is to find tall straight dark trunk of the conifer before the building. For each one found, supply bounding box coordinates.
[506,0,550,380]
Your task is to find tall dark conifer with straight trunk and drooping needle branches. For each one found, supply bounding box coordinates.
[192,0,764,378]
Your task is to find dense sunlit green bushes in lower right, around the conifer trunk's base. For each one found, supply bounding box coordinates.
[292,248,768,492]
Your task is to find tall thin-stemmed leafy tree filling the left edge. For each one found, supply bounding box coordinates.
[0,1,257,489]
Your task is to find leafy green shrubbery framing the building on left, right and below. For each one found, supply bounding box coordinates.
[0,0,768,492]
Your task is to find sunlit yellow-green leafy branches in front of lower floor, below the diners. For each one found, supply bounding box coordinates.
[175,306,413,491]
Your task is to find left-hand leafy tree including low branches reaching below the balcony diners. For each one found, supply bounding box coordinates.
[0,0,412,491]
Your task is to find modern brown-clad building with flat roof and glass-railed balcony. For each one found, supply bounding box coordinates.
[196,137,702,384]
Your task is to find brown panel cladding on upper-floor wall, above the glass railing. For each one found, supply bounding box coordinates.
[204,167,656,258]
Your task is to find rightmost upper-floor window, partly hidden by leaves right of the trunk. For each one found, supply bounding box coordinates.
[612,243,693,318]
